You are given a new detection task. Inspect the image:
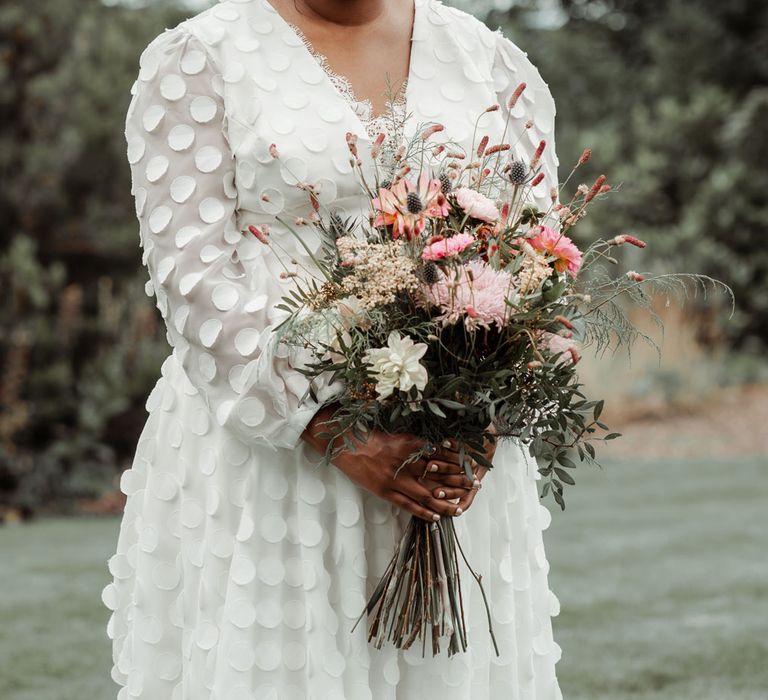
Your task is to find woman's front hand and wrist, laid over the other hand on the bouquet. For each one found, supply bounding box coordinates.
[303,411,467,522]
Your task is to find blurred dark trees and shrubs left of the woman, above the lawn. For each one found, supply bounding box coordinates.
[0,0,185,511]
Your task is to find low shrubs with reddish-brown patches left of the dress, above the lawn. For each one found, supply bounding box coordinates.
[0,236,167,511]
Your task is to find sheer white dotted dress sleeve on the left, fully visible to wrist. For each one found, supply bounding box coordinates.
[126,25,332,449]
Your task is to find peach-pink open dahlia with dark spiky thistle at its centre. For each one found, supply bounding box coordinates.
[373,171,448,240]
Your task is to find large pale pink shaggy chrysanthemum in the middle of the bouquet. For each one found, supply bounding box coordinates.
[421,260,513,330]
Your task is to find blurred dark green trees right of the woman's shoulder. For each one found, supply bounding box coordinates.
[488,0,768,349]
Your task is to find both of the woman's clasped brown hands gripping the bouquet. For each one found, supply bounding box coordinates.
[302,405,496,522]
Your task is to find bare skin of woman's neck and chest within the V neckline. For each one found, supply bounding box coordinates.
[269,0,414,115]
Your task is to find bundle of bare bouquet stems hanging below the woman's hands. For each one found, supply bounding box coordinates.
[352,516,499,657]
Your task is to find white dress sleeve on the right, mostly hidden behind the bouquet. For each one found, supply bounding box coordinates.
[492,29,559,222]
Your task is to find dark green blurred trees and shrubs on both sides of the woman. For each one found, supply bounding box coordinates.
[0,0,768,516]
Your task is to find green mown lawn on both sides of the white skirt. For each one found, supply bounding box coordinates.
[0,458,768,700]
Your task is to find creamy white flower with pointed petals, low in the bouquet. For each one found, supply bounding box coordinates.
[363,331,428,399]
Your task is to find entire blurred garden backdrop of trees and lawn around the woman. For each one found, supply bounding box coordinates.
[0,0,768,700]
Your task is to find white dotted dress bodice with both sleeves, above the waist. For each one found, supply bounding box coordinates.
[126,0,557,447]
